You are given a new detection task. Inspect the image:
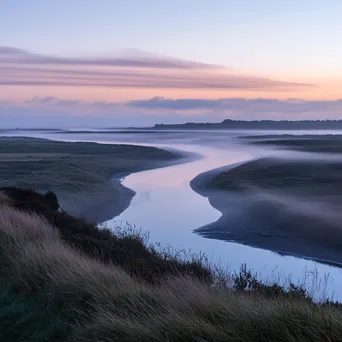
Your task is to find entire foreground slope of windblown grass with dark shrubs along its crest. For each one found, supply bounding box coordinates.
[0,189,342,342]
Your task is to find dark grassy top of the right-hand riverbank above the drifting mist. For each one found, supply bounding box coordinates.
[210,158,342,196]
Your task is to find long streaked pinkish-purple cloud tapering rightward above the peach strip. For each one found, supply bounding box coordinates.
[0,47,312,91]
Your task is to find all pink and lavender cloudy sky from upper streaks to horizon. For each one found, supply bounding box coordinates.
[0,47,342,125]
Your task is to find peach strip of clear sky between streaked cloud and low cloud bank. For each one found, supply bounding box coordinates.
[0,79,342,102]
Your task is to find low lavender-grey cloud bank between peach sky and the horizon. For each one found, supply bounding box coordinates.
[0,96,342,126]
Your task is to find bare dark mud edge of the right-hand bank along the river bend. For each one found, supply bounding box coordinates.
[190,158,342,268]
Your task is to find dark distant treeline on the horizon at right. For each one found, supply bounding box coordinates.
[153,119,342,130]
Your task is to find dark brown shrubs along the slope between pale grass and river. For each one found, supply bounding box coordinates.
[1,187,212,282]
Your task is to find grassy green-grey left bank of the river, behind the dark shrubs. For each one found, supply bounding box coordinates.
[0,137,188,222]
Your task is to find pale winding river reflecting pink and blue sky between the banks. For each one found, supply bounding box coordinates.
[107,145,342,298]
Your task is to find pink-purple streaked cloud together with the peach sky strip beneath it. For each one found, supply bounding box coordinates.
[0,47,342,101]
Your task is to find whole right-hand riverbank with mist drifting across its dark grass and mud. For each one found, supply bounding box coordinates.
[190,159,342,267]
